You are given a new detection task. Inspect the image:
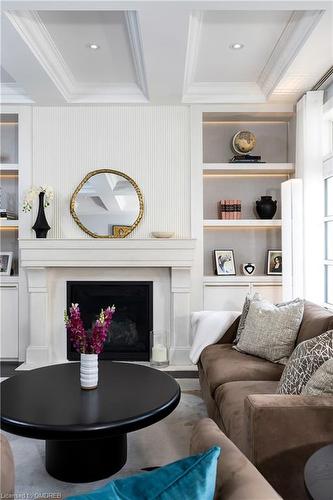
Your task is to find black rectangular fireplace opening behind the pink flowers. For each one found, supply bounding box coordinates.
[67,281,153,361]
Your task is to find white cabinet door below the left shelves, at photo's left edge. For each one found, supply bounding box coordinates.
[0,283,19,359]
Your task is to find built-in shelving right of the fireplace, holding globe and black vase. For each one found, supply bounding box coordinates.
[193,104,295,309]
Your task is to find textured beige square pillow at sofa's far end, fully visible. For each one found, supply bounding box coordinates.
[234,299,304,364]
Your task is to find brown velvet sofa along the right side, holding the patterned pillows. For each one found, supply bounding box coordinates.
[198,302,333,500]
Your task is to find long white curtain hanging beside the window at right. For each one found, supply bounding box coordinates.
[295,91,324,304]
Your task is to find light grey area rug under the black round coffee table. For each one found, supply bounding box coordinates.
[4,379,207,498]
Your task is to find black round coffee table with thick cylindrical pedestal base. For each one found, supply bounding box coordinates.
[1,361,180,483]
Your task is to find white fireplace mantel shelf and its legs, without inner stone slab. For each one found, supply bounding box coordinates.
[19,239,195,369]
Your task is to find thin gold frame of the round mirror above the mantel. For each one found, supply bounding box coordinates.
[70,168,144,238]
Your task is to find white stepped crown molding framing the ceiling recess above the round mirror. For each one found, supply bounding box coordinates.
[6,11,148,104]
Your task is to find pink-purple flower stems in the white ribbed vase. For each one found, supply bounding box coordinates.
[65,304,115,354]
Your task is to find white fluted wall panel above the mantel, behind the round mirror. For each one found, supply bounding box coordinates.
[32,106,191,238]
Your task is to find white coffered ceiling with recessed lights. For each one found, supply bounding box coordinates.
[1,0,333,104]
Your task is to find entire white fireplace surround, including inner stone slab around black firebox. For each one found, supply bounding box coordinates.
[20,238,196,370]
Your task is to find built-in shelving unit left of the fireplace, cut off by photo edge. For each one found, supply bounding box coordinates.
[0,106,29,360]
